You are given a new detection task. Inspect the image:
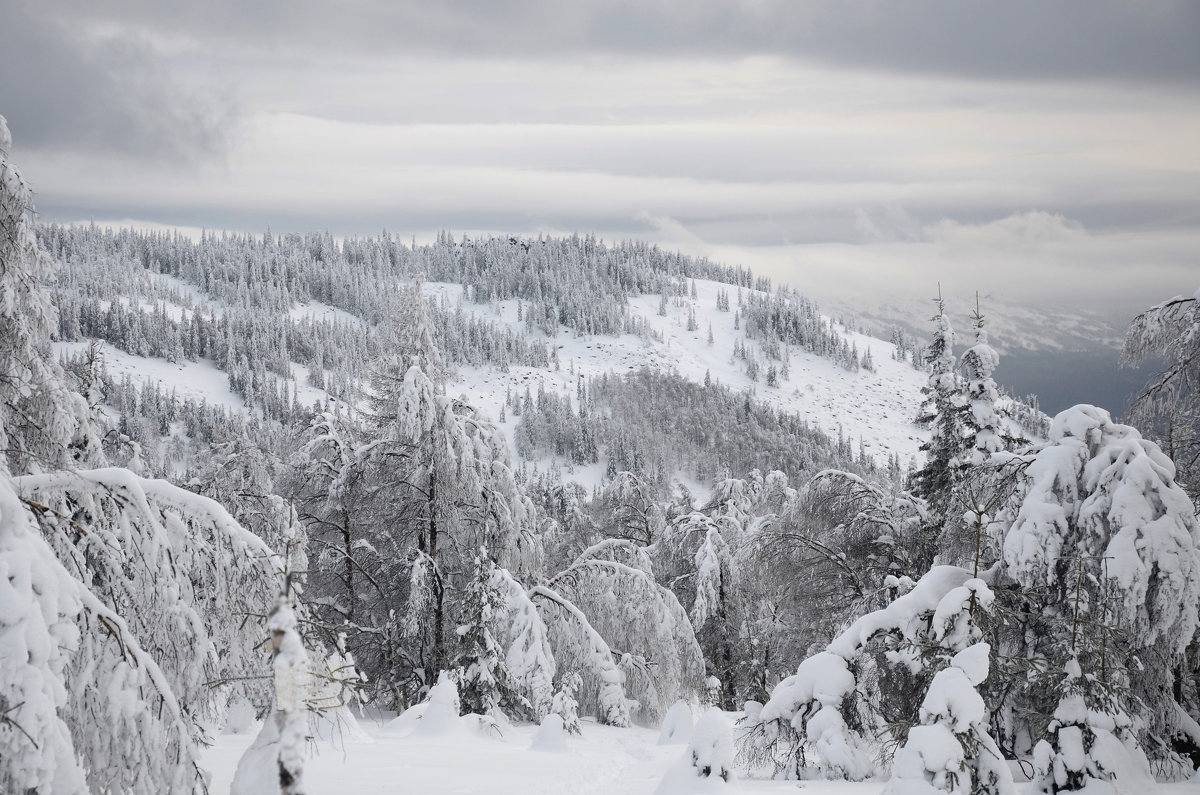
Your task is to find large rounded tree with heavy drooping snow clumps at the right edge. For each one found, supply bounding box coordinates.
[996,406,1200,746]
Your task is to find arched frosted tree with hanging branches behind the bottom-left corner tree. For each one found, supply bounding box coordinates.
[16,470,278,718]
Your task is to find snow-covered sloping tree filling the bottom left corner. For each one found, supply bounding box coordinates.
[0,473,204,795]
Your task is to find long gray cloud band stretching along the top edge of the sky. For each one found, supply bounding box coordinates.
[46,0,1200,84]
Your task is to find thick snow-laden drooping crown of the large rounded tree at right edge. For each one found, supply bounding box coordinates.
[1001,406,1200,653]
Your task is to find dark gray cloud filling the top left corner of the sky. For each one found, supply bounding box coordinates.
[0,0,230,160]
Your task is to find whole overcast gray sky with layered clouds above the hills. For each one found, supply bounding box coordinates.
[0,0,1200,309]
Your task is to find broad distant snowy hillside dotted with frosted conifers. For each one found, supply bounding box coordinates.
[47,228,928,494]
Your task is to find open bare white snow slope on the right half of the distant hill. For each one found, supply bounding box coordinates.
[424,279,929,475]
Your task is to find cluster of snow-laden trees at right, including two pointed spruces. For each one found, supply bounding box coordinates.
[744,283,1200,793]
